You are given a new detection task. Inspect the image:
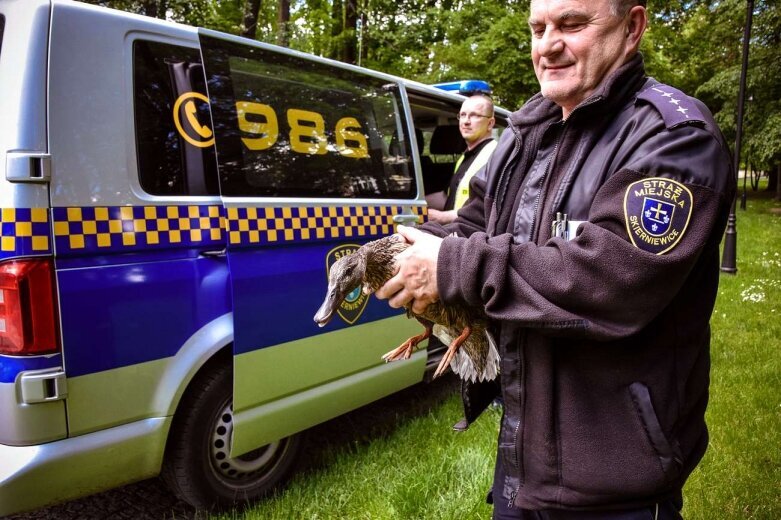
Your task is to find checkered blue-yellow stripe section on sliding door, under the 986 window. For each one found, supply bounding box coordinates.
[227,206,426,246]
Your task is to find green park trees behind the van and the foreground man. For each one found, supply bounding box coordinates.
[80,0,781,191]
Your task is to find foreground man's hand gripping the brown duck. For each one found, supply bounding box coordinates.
[376,226,442,314]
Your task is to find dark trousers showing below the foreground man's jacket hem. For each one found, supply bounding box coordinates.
[488,450,683,520]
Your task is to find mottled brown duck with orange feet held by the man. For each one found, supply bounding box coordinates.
[314,235,499,382]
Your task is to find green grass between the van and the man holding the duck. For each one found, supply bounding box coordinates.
[214,376,499,520]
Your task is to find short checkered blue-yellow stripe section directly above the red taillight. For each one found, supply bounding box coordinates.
[0,208,51,258]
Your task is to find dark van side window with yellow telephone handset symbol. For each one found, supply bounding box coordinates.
[133,40,219,195]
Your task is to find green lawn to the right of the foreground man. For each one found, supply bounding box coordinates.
[684,188,781,519]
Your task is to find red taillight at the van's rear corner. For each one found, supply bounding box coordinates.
[0,258,59,356]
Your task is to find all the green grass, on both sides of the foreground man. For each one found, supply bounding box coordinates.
[212,185,781,520]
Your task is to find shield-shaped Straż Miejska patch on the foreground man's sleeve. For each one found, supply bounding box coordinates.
[624,177,694,255]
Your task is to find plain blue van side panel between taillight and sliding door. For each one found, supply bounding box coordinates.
[57,247,230,377]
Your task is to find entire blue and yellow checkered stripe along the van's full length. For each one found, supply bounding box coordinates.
[0,205,426,258]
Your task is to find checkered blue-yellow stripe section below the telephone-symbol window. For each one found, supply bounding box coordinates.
[52,205,225,253]
